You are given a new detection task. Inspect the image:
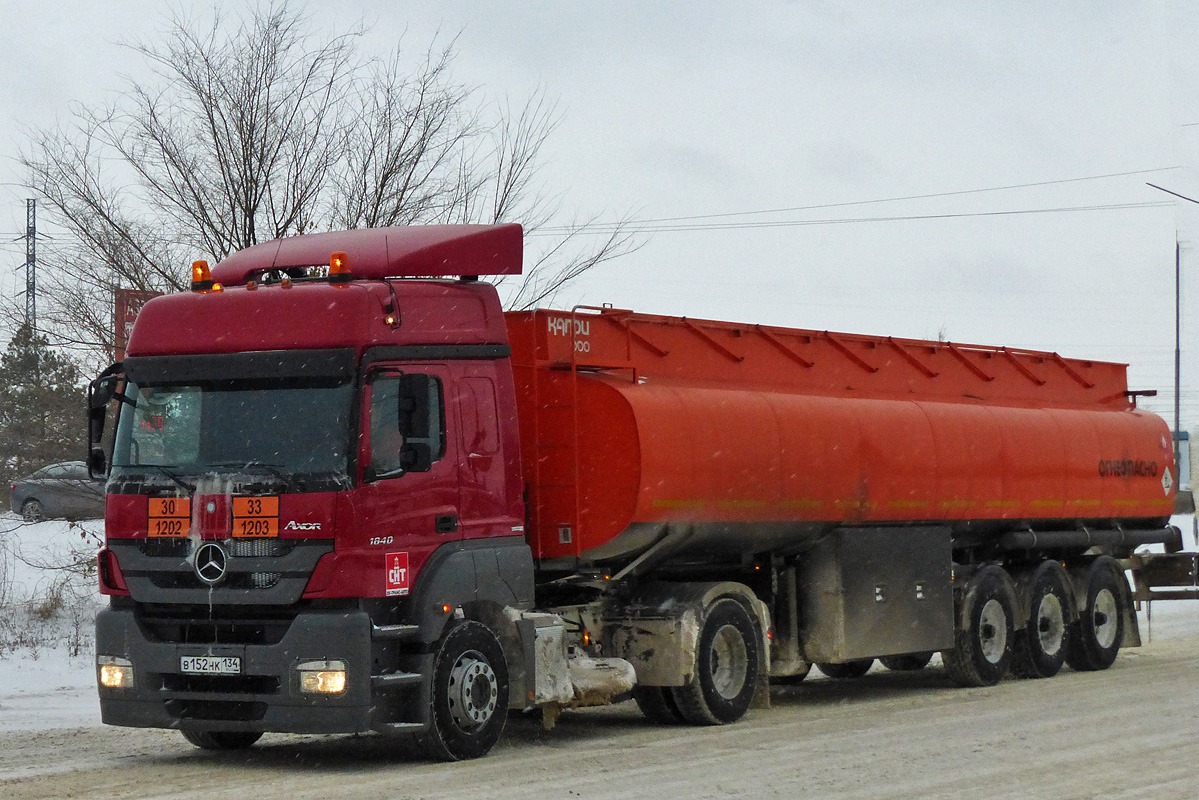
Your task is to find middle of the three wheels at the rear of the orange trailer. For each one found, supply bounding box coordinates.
[1012,561,1072,678]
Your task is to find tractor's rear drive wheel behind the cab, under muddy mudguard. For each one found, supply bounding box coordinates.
[671,597,760,724]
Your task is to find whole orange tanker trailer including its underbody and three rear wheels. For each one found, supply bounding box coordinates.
[506,307,1181,720]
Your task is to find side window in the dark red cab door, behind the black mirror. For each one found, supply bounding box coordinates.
[370,373,445,479]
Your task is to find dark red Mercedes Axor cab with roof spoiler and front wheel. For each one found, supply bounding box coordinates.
[91,225,561,757]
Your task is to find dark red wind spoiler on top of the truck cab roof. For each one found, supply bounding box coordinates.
[212,224,524,285]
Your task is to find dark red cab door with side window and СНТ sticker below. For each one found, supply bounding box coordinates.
[356,363,462,596]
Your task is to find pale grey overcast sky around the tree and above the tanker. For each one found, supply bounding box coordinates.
[0,0,1199,427]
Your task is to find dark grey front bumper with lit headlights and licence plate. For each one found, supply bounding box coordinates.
[96,608,400,733]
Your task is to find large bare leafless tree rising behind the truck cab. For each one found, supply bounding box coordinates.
[18,4,637,367]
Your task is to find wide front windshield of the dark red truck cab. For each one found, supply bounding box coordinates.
[113,380,353,481]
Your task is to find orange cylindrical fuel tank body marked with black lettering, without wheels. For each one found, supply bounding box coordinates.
[506,308,1175,565]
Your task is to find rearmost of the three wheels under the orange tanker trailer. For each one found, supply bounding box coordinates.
[1066,557,1128,672]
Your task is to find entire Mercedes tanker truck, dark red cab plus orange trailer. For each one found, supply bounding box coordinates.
[90,225,1194,759]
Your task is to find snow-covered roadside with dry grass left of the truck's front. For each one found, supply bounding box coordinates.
[0,513,104,733]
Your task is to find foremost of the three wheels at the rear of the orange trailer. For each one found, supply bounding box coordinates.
[941,566,1016,686]
